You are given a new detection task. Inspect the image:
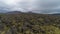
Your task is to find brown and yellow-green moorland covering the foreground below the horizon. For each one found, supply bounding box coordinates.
[0,13,60,34]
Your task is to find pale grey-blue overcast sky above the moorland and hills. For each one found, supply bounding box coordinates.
[0,0,60,14]
